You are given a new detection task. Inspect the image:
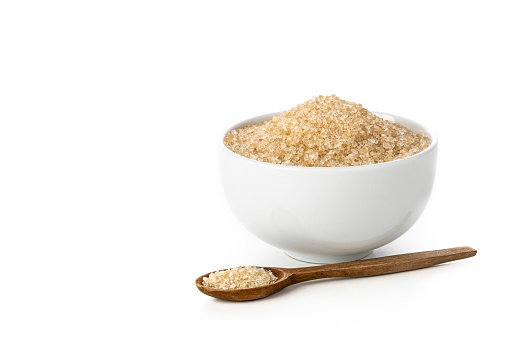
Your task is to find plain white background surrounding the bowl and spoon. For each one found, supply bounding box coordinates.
[0,0,509,338]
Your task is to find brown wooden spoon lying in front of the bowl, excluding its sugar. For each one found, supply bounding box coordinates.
[196,247,477,301]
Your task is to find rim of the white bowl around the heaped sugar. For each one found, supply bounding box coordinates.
[219,111,438,171]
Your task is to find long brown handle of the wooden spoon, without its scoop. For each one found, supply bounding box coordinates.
[287,247,477,284]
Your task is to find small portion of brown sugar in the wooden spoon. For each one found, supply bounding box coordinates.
[203,266,277,290]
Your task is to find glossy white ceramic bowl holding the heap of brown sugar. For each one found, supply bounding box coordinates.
[219,113,437,263]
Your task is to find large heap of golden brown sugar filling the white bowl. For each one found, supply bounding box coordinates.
[223,95,431,167]
